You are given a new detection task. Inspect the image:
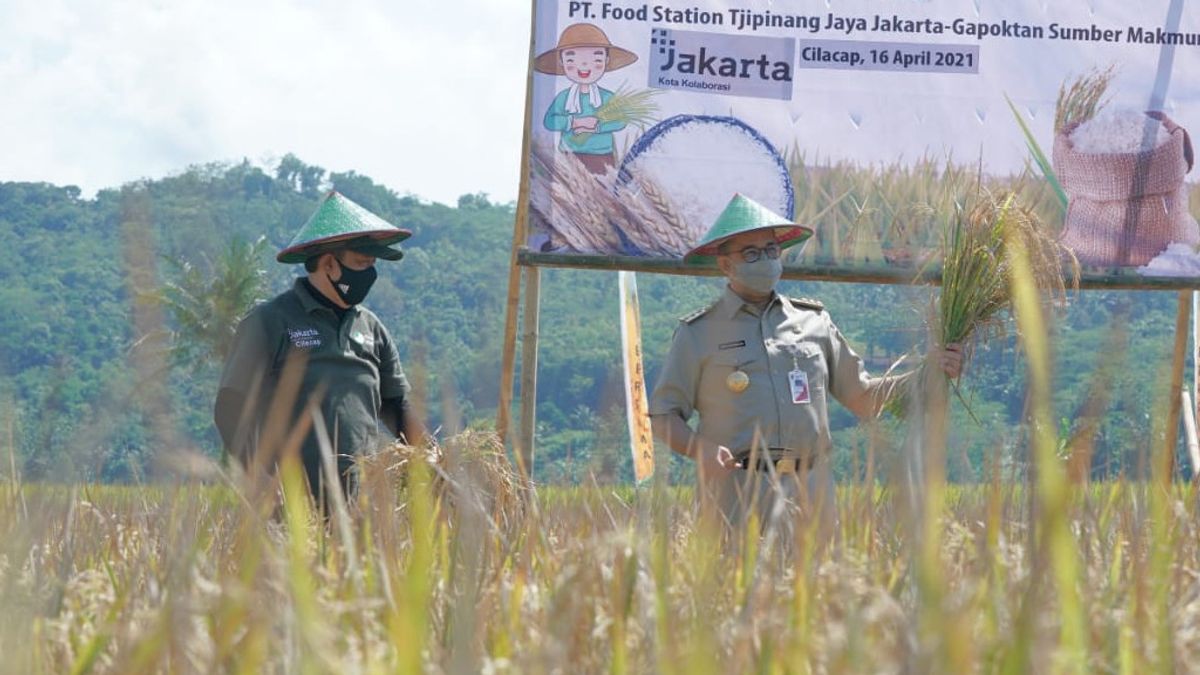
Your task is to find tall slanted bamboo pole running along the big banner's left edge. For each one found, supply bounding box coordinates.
[496,0,538,444]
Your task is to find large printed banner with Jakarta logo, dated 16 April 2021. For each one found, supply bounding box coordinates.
[527,0,1200,281]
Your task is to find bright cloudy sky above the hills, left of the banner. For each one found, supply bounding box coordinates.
[0,0,529,204]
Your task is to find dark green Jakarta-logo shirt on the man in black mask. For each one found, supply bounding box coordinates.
[221,277,408,464]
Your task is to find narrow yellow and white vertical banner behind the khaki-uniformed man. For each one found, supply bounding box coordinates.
[617,271,654,483]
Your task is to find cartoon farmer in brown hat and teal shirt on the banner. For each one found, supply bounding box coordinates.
[533,24,637,174]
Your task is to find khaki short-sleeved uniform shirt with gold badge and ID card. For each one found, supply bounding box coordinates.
[649,287,898,458]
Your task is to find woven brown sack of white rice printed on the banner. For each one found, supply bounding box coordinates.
[1052,109,1200,267]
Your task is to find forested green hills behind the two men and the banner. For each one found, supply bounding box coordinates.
[0,155,1186,483]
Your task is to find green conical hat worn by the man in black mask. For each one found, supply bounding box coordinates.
[275,190,413,264]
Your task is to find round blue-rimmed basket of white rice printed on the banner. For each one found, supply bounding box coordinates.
[617,115,796,255]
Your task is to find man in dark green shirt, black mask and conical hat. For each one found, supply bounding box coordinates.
[214,192,424,500]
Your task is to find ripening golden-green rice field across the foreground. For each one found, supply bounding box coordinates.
[0,435,1200,674]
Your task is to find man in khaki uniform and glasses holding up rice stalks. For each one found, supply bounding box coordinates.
[650,195,962,526]
